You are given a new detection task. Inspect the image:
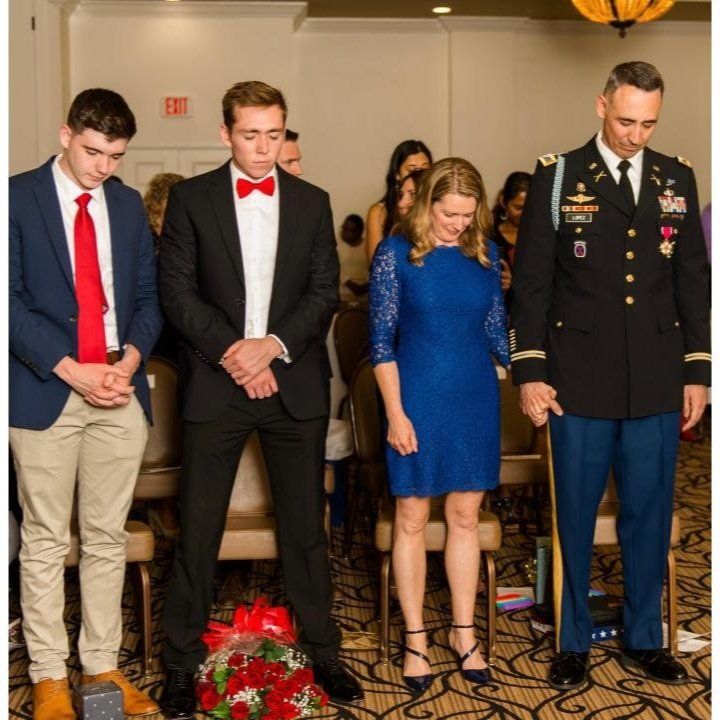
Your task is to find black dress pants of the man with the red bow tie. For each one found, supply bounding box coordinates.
[163,388,340,670]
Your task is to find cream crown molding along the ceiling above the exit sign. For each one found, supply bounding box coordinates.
[74,0,307,19]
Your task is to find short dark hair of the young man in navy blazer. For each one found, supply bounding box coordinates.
[67,88,137,140]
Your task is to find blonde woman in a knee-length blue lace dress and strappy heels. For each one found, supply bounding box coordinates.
[370,158,509,693]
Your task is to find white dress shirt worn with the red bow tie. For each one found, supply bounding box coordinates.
[230,162,288,360]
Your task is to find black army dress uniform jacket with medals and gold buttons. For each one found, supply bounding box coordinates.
[510,137,710,419]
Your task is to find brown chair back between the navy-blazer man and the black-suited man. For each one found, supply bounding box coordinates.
[140,356,182,472]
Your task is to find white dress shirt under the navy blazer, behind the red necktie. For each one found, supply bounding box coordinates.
[52,155,120,352]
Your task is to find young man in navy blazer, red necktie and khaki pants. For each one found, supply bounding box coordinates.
[9,89,162,720]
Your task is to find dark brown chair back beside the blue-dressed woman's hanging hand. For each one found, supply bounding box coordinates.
[349,358,385,463]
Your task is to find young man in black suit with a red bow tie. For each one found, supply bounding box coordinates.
[160,81,362,718]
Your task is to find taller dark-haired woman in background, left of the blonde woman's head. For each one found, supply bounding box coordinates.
[365,140,432,262]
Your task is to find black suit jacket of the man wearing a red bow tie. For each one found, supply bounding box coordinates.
[159,162,339,422]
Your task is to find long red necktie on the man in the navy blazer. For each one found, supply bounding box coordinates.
[75,193,107,363]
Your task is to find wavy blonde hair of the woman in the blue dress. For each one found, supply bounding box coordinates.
[401,158,492,267]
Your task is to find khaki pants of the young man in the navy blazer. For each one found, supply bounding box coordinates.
[10,392,147,683]
